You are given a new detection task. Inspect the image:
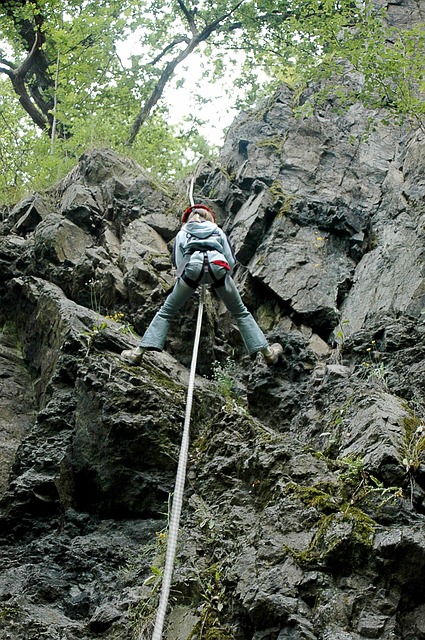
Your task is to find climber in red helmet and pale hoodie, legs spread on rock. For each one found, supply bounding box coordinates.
[121,204,283,365]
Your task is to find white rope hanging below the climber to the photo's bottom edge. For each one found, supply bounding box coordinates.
[149,286,204,640]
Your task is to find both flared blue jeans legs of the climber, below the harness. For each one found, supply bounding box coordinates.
[140,275,268,353]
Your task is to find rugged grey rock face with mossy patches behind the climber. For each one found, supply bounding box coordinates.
[0,31,425,640]
